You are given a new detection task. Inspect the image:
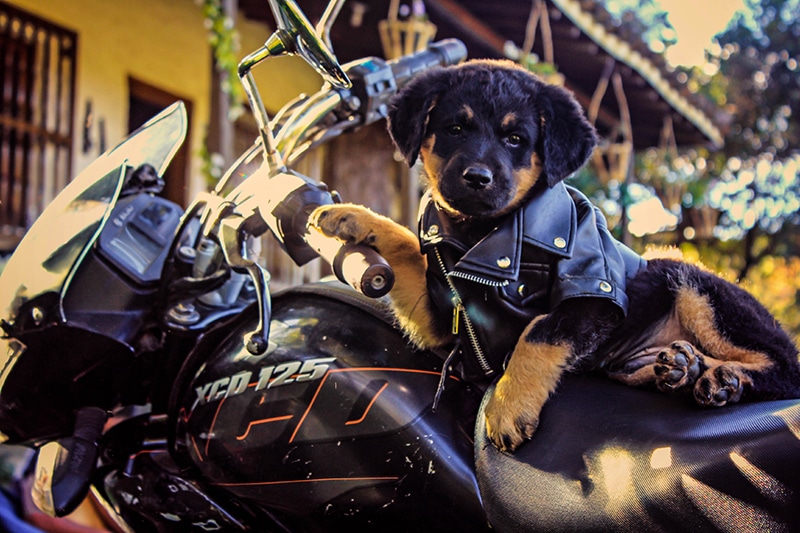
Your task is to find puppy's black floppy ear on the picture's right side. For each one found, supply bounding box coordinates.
[536,85,597,187]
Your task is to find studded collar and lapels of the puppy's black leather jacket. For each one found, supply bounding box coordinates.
[419,182,577,282]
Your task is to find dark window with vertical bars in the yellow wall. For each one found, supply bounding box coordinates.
[0,2,78,252]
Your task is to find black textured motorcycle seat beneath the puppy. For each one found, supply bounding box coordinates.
[475,375,800,532]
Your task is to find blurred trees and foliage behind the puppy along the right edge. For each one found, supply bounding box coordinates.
[596,0,800,334]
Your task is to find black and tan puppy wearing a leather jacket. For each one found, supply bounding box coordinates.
[312,57,800,450]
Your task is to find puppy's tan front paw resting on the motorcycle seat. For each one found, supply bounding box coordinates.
[485,374,543,452]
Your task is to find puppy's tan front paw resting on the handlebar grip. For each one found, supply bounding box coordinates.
[308,204,379,245]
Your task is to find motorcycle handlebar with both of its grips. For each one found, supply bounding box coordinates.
[255,39,467,298]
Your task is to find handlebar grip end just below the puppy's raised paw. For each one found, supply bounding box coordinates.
[331,244,394,298]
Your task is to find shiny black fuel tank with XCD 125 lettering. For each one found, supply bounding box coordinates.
[175,286,485,530]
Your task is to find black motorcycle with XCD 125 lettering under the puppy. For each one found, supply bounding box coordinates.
[0,0,800,532]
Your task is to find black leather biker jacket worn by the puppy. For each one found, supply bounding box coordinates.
[419,183,646,381]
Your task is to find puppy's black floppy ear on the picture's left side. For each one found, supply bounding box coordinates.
[388,68,449,166]
